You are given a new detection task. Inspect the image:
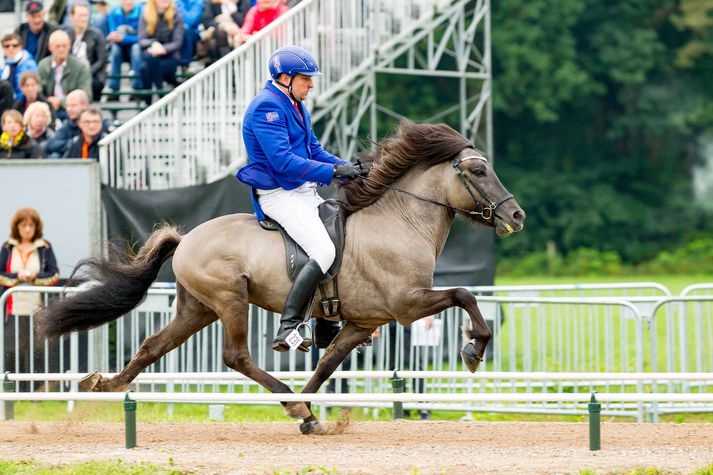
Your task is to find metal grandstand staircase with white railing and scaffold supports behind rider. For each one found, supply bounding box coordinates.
[100,0,492,190]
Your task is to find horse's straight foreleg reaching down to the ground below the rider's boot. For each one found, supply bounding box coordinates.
[300,322,375,434]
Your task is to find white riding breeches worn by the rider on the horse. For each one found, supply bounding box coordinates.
[258,183,336,272]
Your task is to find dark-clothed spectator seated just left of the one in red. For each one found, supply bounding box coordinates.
[200,0,250,64]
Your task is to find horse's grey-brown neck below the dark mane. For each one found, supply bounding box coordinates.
[350,166,453,258]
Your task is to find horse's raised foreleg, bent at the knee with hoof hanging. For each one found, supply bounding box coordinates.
[409,288,492,373]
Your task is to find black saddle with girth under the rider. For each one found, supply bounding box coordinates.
[260,199,344,317]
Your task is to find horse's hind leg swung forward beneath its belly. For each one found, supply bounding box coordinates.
[216,280,312,419]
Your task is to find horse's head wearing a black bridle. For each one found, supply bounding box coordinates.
[448,148,525,236]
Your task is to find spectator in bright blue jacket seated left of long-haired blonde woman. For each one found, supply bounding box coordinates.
[107,0,142,91]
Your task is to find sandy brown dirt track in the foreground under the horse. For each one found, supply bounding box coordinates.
[0,421,713,475]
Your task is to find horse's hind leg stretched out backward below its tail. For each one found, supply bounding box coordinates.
[80,284,218,391]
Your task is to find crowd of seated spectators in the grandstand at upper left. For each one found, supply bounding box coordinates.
[0,0,299,159]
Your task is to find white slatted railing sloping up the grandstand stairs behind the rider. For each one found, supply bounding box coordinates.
[100,0,465,190]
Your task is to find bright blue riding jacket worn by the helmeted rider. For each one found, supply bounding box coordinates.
[237,81,345,220]
